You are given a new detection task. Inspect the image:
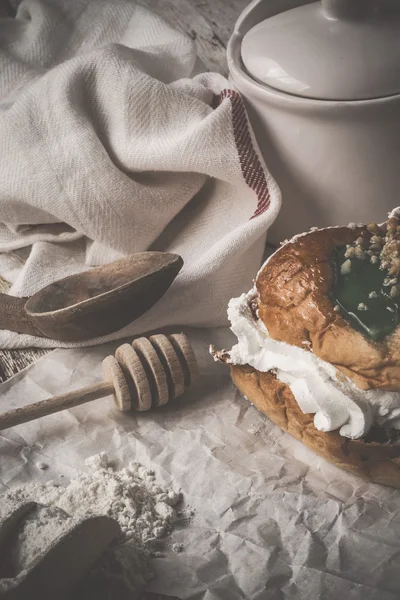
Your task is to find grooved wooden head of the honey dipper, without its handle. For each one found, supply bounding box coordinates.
[103,334,198,411]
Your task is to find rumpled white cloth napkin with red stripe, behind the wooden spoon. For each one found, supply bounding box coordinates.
[0,0,280,348]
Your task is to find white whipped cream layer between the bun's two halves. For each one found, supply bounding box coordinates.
[228,289,400,439]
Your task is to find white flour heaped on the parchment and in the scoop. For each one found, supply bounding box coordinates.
[0,453,184,600]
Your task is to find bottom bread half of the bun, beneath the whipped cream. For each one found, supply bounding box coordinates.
[231,365,400,488]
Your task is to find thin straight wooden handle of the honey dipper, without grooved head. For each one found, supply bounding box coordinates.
[0,381,114,431]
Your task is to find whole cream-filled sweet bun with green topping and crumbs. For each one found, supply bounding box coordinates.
[213,209,400,488]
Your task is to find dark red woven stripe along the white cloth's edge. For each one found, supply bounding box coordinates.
[213,89,270,219]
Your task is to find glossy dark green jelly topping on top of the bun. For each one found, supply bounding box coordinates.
[332,248,399,341]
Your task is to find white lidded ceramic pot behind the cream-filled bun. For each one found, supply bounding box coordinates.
[228,0,400,242]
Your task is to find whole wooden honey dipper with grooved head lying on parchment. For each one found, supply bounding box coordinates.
[0,333,198,430]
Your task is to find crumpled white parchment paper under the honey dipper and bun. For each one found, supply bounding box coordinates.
[0,329,400,600]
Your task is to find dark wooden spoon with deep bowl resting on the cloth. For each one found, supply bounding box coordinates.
[0,252,183,342]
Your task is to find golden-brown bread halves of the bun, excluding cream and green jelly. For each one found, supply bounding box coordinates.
[225,222,400,488]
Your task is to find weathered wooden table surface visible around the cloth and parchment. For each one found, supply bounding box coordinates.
[0,0,250,381]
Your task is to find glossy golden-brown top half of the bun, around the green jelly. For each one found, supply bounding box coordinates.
[256,227,400,392]
